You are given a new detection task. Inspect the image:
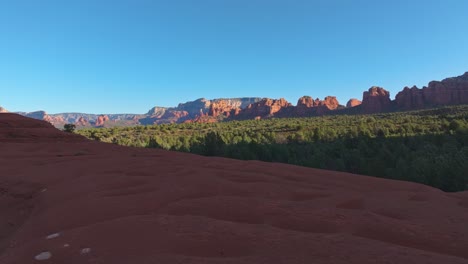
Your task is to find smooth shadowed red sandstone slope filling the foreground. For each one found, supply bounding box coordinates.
[0,114,468,264]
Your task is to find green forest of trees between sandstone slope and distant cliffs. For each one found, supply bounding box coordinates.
[76,105,468,192]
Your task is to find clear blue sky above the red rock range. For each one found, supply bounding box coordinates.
[0,0,468,113]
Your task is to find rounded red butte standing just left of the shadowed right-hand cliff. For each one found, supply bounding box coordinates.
[361,86,392,113]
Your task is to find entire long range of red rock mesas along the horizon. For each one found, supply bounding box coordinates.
[9,72,468,128]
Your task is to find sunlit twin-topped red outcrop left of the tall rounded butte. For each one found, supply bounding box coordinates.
[294,96,340,116]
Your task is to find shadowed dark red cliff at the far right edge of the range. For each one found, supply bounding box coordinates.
[395,72,468,110]
